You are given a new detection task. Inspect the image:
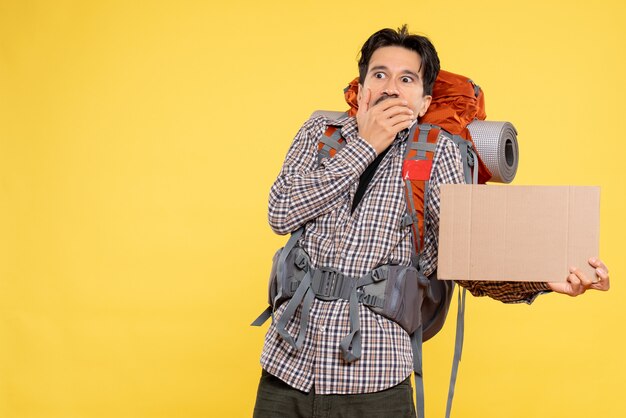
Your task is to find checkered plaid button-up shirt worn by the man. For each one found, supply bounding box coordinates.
[261,117,547,394]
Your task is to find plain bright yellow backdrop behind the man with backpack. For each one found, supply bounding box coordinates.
[0,0,626,418]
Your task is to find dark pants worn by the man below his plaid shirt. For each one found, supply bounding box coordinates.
[254,370,415,418]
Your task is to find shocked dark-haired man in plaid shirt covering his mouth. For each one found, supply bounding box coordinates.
[254,26,609,418]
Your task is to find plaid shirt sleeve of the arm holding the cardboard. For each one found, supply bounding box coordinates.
[424,137,550,304]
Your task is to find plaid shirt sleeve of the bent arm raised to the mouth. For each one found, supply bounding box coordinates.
[268,118,376,235]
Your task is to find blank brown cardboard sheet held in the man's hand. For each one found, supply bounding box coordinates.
[437,184,600,282]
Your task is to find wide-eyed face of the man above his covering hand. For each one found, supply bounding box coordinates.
[358,46,432,116]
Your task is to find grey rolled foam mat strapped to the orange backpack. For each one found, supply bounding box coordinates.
[467,120,519,183]
